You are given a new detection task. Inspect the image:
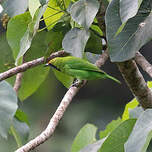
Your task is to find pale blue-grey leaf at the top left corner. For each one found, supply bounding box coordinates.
[2,0,28,17]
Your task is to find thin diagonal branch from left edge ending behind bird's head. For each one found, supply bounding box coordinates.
[0,51,66,81]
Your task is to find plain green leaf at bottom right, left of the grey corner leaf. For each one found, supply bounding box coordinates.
[99,119,137,152]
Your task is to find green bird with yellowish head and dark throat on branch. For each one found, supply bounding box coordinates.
[46,56,120,83]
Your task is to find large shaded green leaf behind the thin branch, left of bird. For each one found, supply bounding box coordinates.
[18,31,49,101]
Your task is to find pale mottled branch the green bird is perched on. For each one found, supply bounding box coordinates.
[16,51,107,152]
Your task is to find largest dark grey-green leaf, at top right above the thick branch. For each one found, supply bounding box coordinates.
[106,0,152,62]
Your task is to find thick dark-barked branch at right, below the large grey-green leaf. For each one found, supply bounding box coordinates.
[117,60,152,109]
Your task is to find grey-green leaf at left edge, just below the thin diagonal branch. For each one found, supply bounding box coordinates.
[0,81,18,138]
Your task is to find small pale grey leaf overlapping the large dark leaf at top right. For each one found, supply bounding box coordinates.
[120,0,143,23]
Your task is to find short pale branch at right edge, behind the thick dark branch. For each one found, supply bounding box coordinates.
[135,52,152,77]
